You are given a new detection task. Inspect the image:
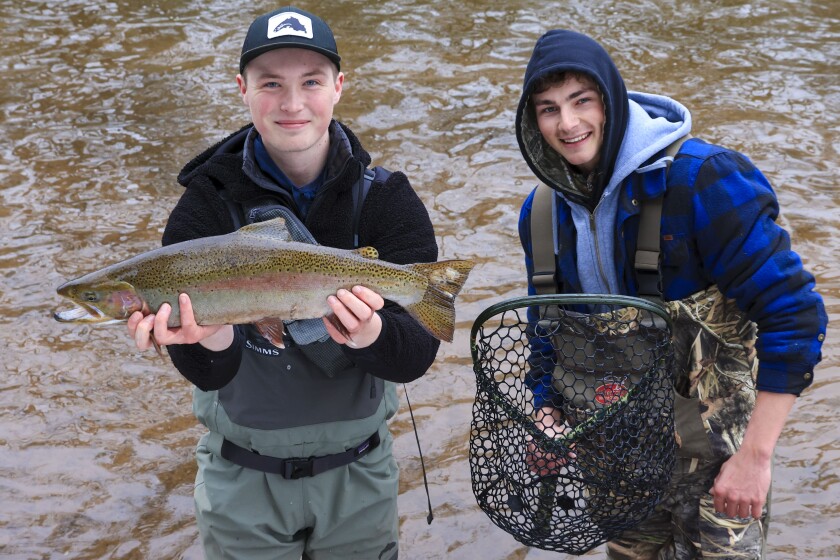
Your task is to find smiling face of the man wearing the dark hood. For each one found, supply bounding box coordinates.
[531,75,606,173]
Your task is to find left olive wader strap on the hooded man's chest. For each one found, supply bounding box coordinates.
[531,185,559,295]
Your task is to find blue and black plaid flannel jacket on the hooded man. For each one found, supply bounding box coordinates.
[519,139,828,407]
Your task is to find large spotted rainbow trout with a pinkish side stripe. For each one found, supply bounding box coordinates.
[55,218,473,343]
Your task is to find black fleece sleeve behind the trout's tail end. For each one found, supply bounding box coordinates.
[343,172,440,383]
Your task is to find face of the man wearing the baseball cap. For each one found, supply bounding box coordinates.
[236,48,344,163]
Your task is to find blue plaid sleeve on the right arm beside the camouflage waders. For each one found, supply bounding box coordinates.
[692,150,828,395]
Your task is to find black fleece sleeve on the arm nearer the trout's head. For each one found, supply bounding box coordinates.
[163,179,244,391]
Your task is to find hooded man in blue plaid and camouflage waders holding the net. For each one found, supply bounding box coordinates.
[516,30,827,560]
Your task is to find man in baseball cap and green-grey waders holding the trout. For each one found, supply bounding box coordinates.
[128,7,450,560]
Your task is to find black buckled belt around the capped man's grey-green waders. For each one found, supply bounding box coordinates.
[222,432,379,479]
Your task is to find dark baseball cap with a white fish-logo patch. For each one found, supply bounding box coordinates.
[239,6,341,74]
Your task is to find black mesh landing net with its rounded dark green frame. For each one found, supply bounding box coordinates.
[470,294,675,554]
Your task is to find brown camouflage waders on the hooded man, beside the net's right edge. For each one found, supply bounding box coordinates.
[607,286,769,560]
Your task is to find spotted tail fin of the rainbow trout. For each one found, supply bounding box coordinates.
[406,260,475,342]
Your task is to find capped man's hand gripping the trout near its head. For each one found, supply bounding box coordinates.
[128,294,233,351]
